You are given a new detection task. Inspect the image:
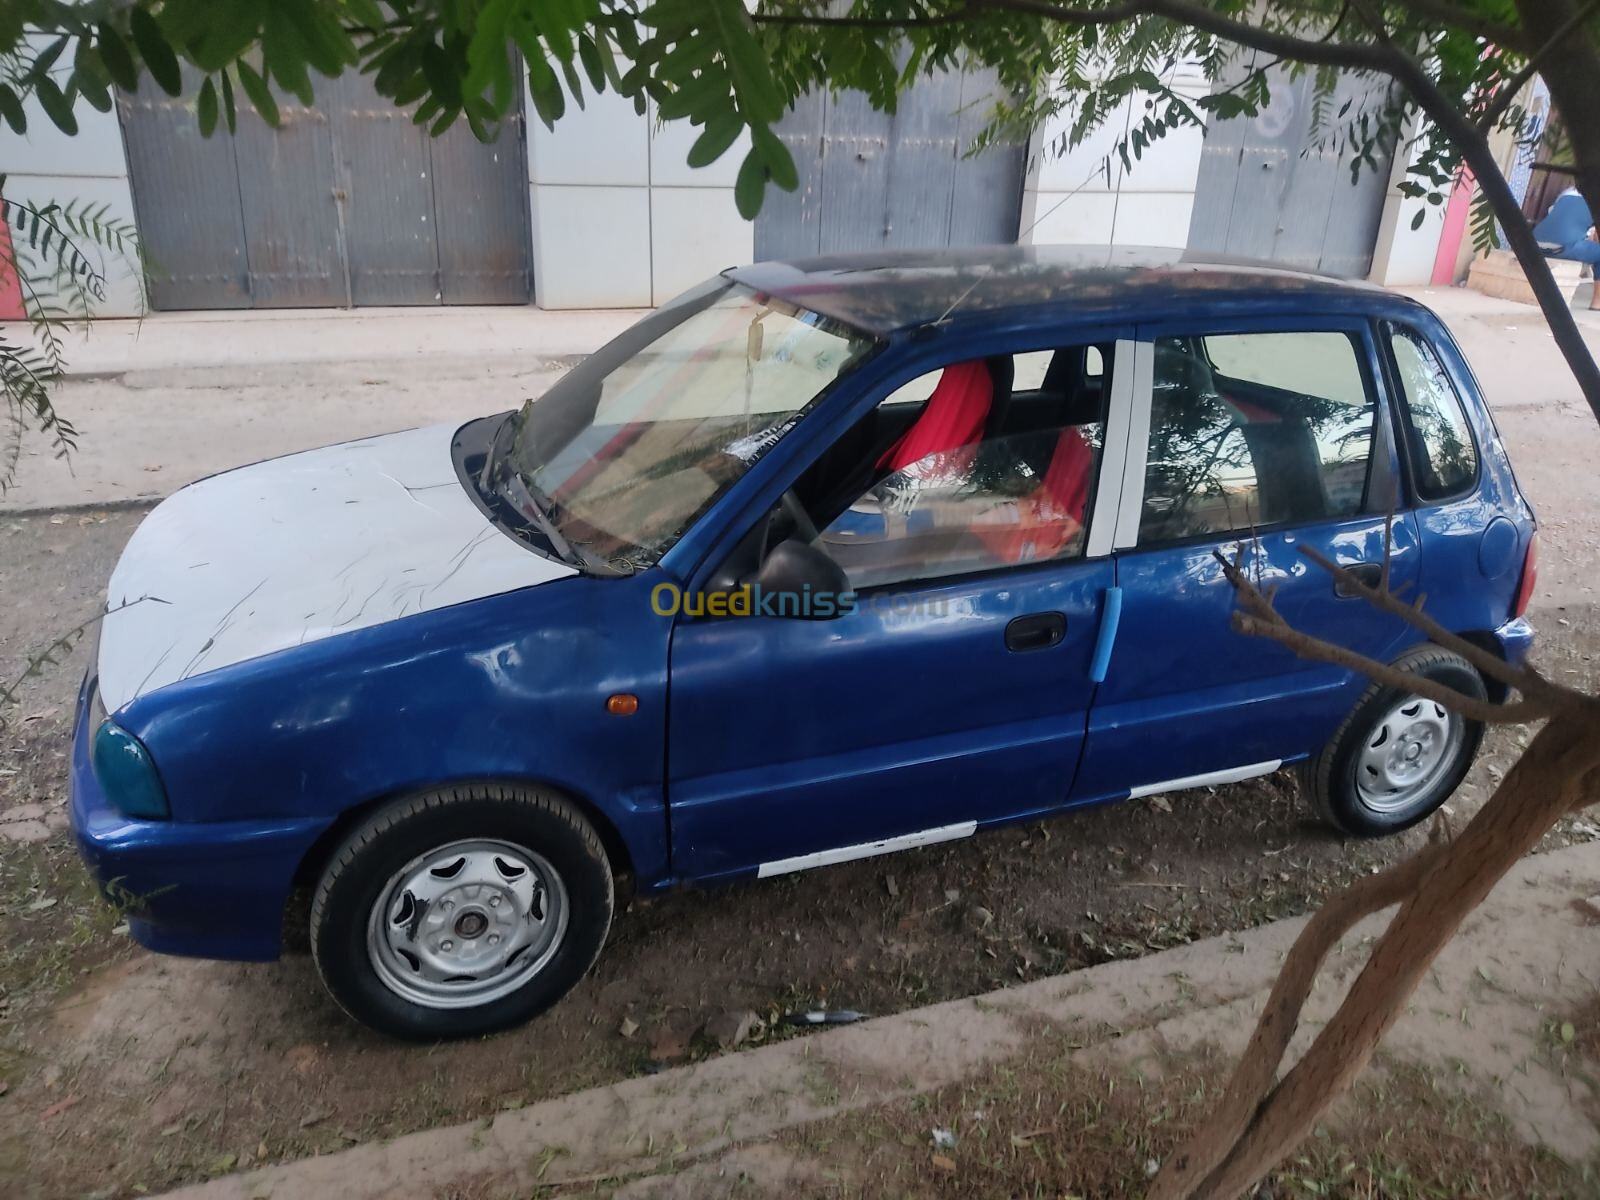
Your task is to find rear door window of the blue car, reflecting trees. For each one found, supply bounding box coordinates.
[1139,333,1376,546]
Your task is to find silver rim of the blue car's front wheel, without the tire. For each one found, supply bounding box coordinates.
[366,840,568,1008]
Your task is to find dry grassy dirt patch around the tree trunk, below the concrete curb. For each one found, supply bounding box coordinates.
[768,1054,1600,1200]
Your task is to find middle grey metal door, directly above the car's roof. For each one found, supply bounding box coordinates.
[755,70,1027,259]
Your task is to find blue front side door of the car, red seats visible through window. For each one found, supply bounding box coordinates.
[667,331,1133,878]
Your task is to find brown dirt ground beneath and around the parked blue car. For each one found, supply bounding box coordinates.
[0,405,1600,1197]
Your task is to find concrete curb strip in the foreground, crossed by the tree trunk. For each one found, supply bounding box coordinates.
[156,843,1600,1200]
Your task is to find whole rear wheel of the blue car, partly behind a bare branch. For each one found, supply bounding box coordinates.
[1299,646,1486,837]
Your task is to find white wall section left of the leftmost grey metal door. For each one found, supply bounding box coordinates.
[0,35,144,317]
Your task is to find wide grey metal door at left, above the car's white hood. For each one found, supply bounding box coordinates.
[118,66,533,309]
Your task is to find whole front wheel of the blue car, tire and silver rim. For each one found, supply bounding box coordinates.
[310,784,614,1042]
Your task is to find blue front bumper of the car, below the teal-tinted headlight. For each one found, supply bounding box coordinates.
[70,677,328,962]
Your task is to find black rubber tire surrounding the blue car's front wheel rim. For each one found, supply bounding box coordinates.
[310,784,614,1042]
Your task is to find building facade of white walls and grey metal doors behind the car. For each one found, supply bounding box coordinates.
[0,51,1443,315]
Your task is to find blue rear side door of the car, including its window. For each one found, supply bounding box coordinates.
[1075,317,1419,800]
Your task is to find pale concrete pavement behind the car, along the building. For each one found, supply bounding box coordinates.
[0,288,1600,512]
